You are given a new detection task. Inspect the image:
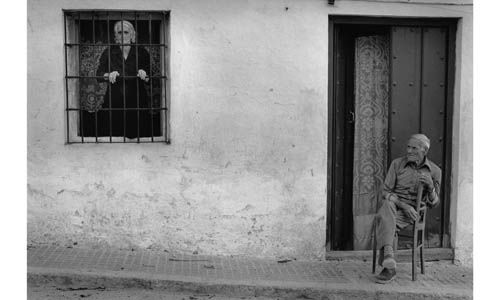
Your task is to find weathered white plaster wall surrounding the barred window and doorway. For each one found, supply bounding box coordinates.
[28,0,472,258]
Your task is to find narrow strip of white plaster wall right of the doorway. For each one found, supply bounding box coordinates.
[450,15,473,266]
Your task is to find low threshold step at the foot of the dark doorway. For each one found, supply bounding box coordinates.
[325,248,454,262]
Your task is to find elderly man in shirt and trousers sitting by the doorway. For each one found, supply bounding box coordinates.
[376,134,441,283]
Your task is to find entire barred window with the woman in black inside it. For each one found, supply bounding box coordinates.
[64,10,169,143]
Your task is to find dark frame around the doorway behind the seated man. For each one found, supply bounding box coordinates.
[325,15,459,252]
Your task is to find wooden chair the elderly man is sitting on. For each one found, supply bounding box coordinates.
[372,185,427,281]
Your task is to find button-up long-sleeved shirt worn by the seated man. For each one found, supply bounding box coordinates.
[382,157,441,207]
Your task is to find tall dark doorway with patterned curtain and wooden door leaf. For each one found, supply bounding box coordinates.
[327,16,456,251]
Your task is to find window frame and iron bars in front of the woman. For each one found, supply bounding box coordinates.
[62,9,170,144]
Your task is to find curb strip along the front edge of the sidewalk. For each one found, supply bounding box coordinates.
[28,267,472,300]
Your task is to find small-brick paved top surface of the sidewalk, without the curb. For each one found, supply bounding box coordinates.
[27,246,473,297]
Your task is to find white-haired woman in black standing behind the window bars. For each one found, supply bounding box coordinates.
[96,20,151,138]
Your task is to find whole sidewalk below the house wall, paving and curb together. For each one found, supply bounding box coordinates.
[28,246,472,299]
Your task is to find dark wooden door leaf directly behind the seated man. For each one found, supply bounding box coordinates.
[389,27,448,247]
